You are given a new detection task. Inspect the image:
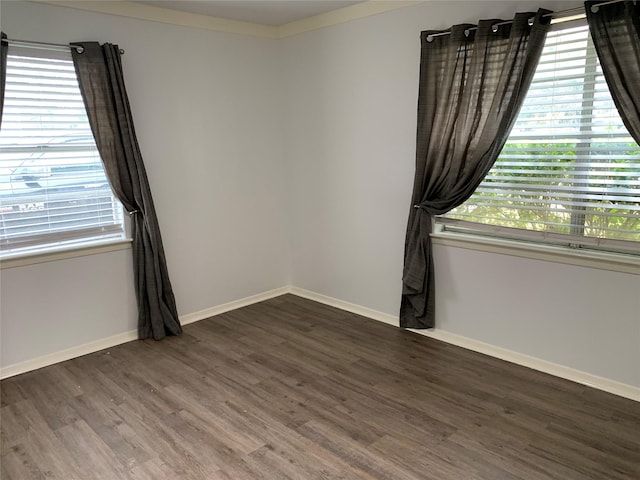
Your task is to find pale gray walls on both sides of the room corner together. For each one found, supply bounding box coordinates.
[0,0,640,387]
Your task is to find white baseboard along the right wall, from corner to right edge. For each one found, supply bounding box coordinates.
[290,287,640,402]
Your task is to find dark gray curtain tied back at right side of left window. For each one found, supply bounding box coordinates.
[71,42,182,340]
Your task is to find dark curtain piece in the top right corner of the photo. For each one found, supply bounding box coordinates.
[585,1,640,143]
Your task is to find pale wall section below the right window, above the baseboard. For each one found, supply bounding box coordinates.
[434,245,640,387]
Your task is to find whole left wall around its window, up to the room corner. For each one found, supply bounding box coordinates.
[0,2,290,366]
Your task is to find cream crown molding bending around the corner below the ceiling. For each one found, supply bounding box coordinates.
[34,0,425,39]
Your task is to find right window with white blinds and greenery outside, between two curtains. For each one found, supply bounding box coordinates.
[438,25,640,253]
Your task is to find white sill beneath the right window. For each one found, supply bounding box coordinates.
[431,232,640,275]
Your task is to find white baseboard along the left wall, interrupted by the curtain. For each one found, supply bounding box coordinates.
[0,287,291,379]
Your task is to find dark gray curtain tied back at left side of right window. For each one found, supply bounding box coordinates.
[400,10,549,328]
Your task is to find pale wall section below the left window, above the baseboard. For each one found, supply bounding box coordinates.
[0,250,137,367]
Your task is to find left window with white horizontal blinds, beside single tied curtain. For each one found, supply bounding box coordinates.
[0,48,124,257]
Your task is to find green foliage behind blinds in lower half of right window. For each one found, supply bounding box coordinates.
[447,142,640,241]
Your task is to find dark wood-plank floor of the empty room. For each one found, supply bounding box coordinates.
[0,295,640,480]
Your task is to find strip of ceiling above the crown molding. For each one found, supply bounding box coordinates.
[133,0,363,26]
